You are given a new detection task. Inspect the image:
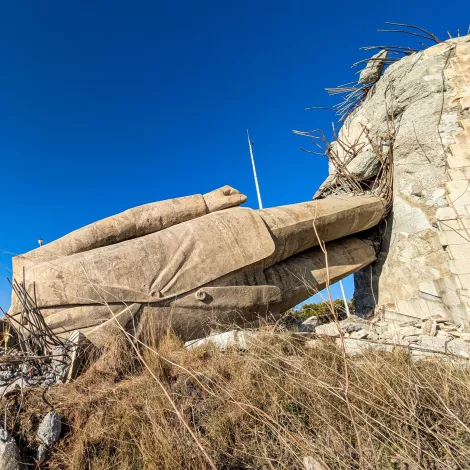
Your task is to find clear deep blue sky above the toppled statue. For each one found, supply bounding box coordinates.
[0,0,470,308]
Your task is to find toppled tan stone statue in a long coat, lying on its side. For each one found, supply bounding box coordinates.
[10,186,384,344]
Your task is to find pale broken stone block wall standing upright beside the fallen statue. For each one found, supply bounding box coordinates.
[325,36,470,323]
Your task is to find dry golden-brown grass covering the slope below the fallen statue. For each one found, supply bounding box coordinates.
[8,329,470,470]
